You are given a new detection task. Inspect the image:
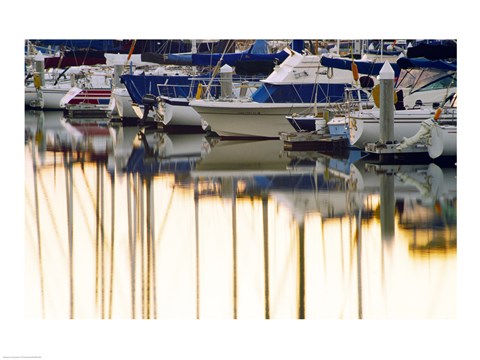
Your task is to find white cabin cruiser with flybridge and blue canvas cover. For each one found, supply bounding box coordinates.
[190,49,362,138]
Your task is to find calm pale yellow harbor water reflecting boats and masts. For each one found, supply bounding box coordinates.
[25,111,457,319]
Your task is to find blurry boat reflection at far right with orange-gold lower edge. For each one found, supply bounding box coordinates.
[348,161,457,251]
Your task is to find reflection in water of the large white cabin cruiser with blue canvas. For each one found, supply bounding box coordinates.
[191,140,360,221]
